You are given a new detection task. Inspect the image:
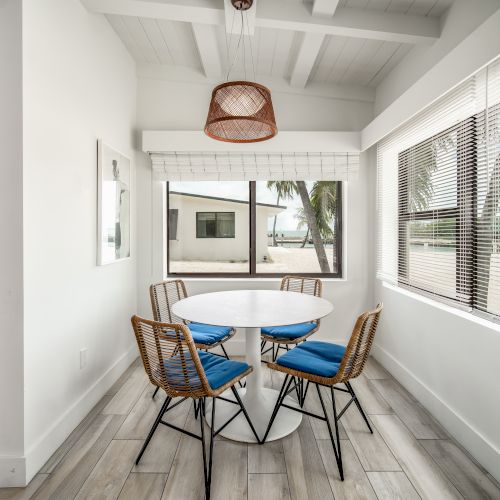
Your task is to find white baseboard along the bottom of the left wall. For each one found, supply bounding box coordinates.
[16,345,139,486]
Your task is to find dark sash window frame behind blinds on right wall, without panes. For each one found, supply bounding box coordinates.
[397,115,477,309]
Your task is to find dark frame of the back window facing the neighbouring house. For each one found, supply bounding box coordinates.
[165,181,344,279]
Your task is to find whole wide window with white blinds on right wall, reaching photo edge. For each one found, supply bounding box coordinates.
[398,97,500,316]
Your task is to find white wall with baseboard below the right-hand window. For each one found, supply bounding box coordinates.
[374,281,500,480]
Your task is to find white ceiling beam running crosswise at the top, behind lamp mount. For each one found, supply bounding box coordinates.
[81,0,440,44]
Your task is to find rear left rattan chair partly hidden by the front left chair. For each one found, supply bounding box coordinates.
[149,280,241,398]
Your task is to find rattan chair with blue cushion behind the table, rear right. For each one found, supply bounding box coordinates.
[260,276,322,362]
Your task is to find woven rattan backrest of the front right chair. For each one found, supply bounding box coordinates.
[336,304,383,382]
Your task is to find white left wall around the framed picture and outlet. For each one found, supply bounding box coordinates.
[23,0,137,479]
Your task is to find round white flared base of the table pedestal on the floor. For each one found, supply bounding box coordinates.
[206,388,302,443]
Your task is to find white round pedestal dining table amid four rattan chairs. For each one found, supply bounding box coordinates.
[172,290,333,443]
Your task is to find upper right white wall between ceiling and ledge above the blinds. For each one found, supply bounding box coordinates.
[375,0,500,115]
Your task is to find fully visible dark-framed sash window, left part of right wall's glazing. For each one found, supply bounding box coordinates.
[398,123,476,304]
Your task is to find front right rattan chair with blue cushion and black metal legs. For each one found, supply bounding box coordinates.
[261,304,382,481]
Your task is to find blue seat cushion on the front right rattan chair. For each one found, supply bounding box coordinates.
[276,340,346,377]
